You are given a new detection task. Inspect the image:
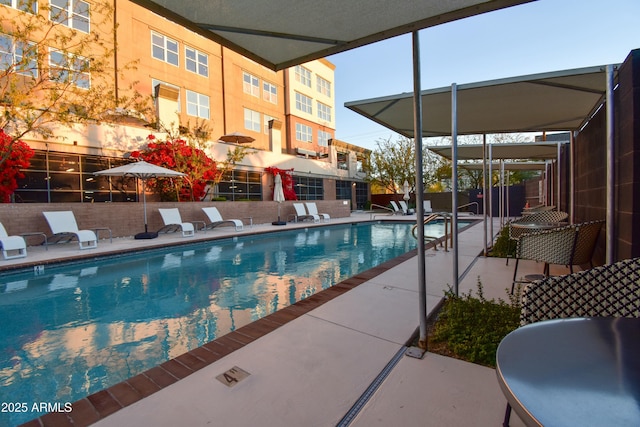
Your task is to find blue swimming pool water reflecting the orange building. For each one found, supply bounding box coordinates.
[0,223,460,425]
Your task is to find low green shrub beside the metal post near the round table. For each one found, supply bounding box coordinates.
[430,280,520,367]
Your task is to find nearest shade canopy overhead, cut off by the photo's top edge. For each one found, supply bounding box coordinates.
[132,0,532,70]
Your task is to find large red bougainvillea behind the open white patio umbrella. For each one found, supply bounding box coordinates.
[131,135,222,202]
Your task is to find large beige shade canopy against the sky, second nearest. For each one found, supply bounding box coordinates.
[345,66,607,138]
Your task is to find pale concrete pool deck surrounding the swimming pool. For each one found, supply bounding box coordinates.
[8,214,560,427]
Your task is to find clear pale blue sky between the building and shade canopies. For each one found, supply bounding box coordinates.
[328,0,640,149]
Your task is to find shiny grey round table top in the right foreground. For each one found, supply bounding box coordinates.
[496,318,640,427]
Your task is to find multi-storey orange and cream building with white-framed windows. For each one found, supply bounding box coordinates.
[0,0,369,208]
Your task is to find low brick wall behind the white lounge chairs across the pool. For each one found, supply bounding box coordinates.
[0,200,351,244]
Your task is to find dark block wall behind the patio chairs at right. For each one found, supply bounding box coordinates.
[575,50,640,264]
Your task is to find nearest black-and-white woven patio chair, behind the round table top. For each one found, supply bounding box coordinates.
[502,258,640,427]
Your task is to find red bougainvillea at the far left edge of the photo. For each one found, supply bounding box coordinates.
[0,130,34,203]
